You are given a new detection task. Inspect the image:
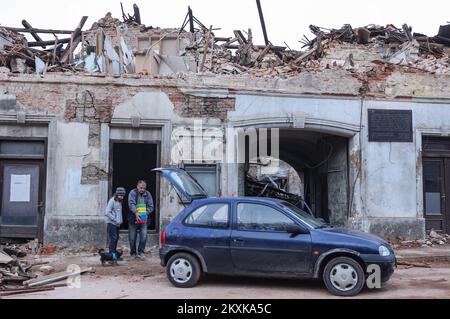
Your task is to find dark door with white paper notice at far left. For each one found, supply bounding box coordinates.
[0,140,45,242]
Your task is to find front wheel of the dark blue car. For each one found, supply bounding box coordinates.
[323,257,366,297]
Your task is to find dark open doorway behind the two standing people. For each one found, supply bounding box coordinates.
[111,143,159,231]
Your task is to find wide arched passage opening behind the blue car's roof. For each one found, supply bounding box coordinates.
[240,129,349,226]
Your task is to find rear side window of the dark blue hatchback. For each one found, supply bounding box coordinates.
[184,204,230,228]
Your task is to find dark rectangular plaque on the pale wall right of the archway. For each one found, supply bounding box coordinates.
[369,110,414,143]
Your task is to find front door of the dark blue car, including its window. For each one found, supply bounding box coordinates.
[230,202,311,274]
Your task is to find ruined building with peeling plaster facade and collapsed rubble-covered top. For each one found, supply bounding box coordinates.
[0,5,450,247]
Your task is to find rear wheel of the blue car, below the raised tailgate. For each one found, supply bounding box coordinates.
[166,253,202,288]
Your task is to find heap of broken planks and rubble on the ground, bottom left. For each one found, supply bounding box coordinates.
[0,242,94,298]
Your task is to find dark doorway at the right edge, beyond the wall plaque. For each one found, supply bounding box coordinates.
[423,137,450,234]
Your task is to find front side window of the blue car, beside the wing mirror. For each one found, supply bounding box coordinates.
[237,203,296,232]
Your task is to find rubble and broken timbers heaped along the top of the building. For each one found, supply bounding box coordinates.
[0,5,450,78]
